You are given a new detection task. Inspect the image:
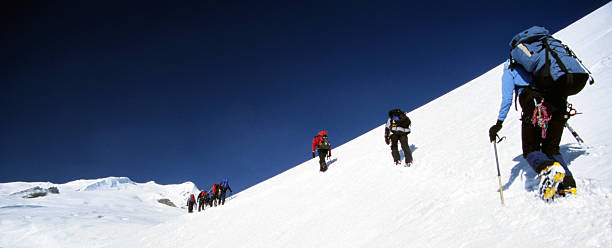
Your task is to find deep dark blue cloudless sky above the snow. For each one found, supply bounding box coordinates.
[0,0,607,190]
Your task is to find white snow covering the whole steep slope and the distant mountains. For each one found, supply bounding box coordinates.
[0,3,612,248]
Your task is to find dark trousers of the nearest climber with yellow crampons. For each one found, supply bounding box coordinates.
[519,89,576,189]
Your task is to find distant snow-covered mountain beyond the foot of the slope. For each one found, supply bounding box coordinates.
[0,177,199,247]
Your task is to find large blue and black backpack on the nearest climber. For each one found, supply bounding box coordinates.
[510,26,594,96]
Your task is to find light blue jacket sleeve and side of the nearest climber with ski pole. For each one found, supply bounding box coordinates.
[497,60,533,121]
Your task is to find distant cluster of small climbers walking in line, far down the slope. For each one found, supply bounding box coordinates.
[187,178,233,213]
